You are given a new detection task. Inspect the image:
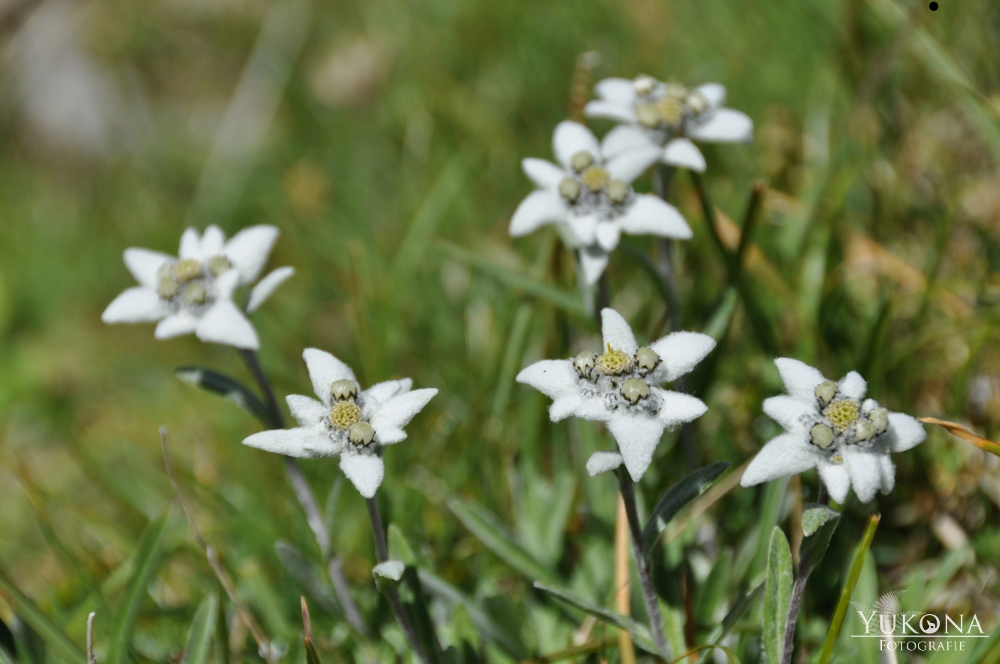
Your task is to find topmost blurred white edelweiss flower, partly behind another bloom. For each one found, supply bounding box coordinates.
[584,76,753,171]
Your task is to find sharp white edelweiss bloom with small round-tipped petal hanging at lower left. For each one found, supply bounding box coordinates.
[517,309,715,482]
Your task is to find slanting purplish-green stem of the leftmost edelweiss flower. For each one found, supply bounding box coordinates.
[239,349,368,636]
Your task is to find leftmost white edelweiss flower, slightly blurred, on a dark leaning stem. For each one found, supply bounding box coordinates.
[101,226,295,350]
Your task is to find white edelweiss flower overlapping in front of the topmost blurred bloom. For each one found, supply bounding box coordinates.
[510,121,691,284]
